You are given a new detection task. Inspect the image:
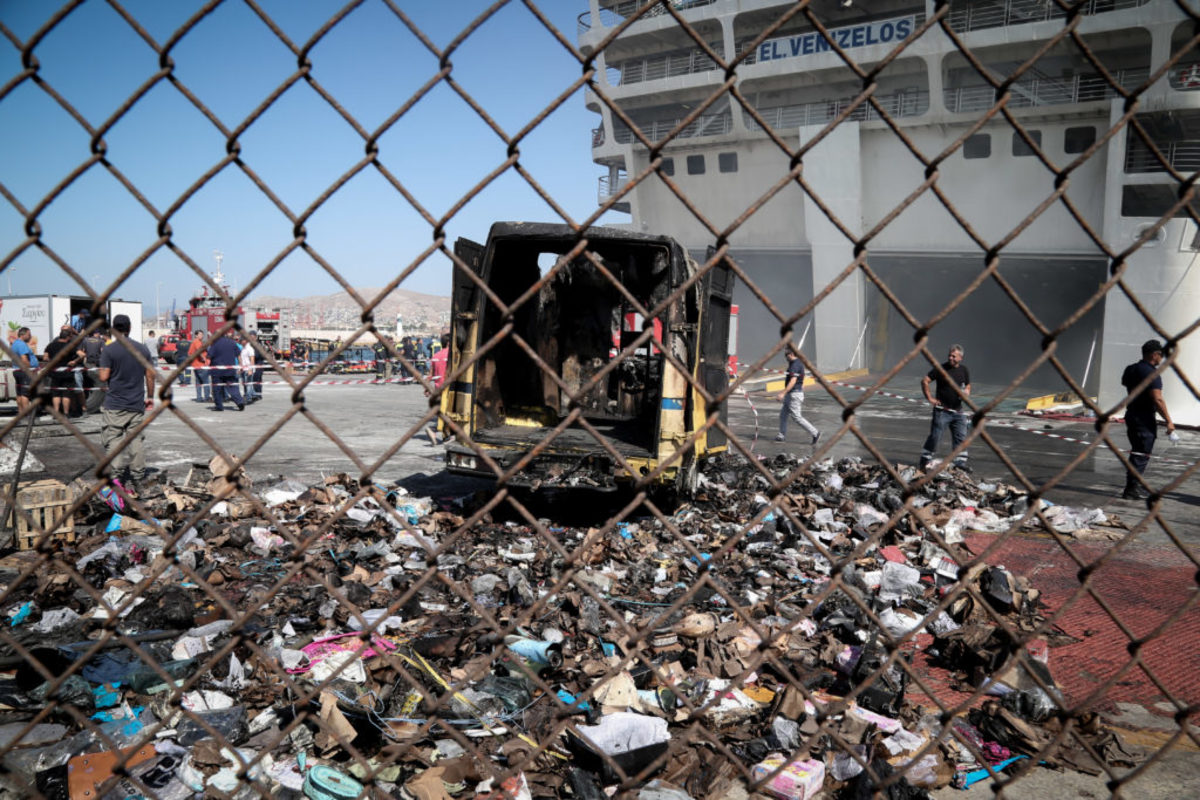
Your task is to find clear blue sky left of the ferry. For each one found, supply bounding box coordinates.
[0,0,623,315]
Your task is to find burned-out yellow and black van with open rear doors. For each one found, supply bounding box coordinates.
[442,222,733,491]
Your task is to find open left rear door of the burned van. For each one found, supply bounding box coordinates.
[442,239,488,429]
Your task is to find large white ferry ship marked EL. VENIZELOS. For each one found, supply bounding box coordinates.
[577,0,1200,425]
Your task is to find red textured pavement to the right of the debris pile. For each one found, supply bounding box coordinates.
[914,534,1200,710]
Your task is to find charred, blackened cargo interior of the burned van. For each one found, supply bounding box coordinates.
[475,231,672,455]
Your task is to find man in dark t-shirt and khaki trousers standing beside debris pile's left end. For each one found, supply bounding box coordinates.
[100,314,155,491]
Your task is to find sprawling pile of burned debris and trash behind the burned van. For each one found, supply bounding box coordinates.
[0,456,1139,800]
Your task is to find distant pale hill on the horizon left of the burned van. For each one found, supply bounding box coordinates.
[246,287,450,331]
